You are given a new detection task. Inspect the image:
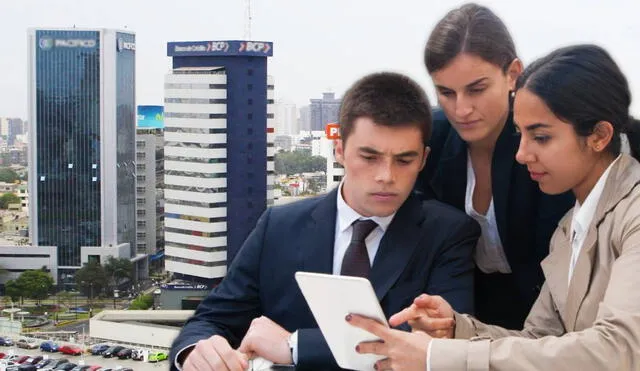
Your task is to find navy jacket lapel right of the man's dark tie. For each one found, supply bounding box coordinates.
[369,195,424,301]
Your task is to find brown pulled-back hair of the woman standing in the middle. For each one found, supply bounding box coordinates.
[424,3,517,73]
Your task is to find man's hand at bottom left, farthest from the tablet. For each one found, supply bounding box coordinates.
[182,335,249,371]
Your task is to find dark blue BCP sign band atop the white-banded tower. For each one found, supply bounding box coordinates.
[167,40,273,57]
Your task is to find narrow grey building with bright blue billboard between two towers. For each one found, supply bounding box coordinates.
[136,106,164,267]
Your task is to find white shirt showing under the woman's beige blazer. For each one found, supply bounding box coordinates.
[567,156,620,284]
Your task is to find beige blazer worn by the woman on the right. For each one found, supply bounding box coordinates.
[431,155,640,371]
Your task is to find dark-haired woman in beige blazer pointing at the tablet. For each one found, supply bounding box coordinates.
[347,45,640,371]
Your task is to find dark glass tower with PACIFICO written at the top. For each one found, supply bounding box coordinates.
[29,28,141,285]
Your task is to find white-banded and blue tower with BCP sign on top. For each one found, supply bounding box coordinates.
[164,41,274,284]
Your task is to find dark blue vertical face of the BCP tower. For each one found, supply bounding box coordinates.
[169,56,267,264]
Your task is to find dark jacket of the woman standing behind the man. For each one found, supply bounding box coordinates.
[416,110,575,329]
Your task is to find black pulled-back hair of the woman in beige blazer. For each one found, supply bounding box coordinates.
[516,45,640,160]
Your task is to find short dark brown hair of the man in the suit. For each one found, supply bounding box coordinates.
[339,72,431,145]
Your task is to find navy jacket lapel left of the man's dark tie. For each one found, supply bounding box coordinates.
[298,187,338,274]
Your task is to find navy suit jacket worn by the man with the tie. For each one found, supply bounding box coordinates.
[170,190,480,370]
